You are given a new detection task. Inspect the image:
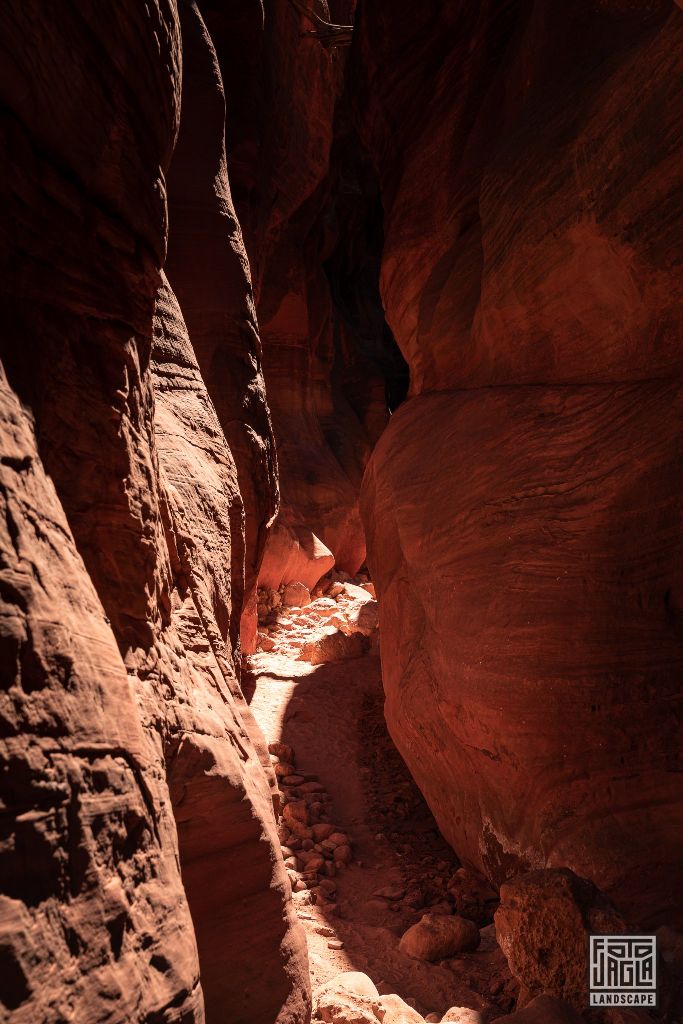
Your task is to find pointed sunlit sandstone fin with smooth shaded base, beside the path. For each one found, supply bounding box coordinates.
[150,280,309,1024]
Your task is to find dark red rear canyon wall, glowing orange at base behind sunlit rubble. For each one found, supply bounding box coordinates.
[203,0,386,606]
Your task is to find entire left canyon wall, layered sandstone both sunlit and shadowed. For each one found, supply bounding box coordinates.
[0,0,309,1024]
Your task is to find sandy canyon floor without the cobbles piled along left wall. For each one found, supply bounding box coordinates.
[244,589,516,1020]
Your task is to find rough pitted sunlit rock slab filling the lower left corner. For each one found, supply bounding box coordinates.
[0,374,204,1024]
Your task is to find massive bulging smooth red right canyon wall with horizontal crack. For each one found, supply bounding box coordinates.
[350,0,683,926]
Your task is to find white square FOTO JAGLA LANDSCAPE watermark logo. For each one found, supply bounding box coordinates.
[589,935,657,1007]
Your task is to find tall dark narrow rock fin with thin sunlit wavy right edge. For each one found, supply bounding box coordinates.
[166,0,278,649]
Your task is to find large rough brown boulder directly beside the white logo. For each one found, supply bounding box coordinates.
[496,868,629,1012]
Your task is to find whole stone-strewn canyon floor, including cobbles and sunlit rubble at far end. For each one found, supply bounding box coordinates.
[243,571,517,1022]
